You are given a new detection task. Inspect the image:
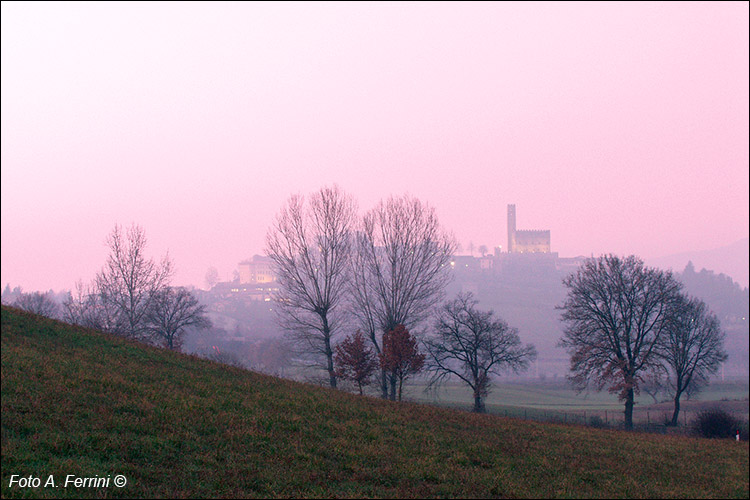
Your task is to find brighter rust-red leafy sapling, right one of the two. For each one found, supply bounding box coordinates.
[380,325,425,401]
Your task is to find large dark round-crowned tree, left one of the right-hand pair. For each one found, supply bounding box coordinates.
[558,255,682,429]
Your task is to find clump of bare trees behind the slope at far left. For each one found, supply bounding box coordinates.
[62,224,210,350]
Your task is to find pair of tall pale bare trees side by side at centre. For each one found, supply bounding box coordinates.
[266,186,455,399]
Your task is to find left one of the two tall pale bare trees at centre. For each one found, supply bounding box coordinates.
[266,186,356,387]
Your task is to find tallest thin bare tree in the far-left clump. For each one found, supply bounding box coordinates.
[95,224,172,339]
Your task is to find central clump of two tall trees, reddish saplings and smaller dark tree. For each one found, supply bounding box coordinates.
[266,186,535,411]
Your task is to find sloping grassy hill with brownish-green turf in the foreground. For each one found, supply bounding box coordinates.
[2,306,748,498]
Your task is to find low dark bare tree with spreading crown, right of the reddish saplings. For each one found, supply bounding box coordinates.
[425,293,536,413]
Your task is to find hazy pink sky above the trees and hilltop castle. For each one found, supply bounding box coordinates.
[1,1,750,291]
